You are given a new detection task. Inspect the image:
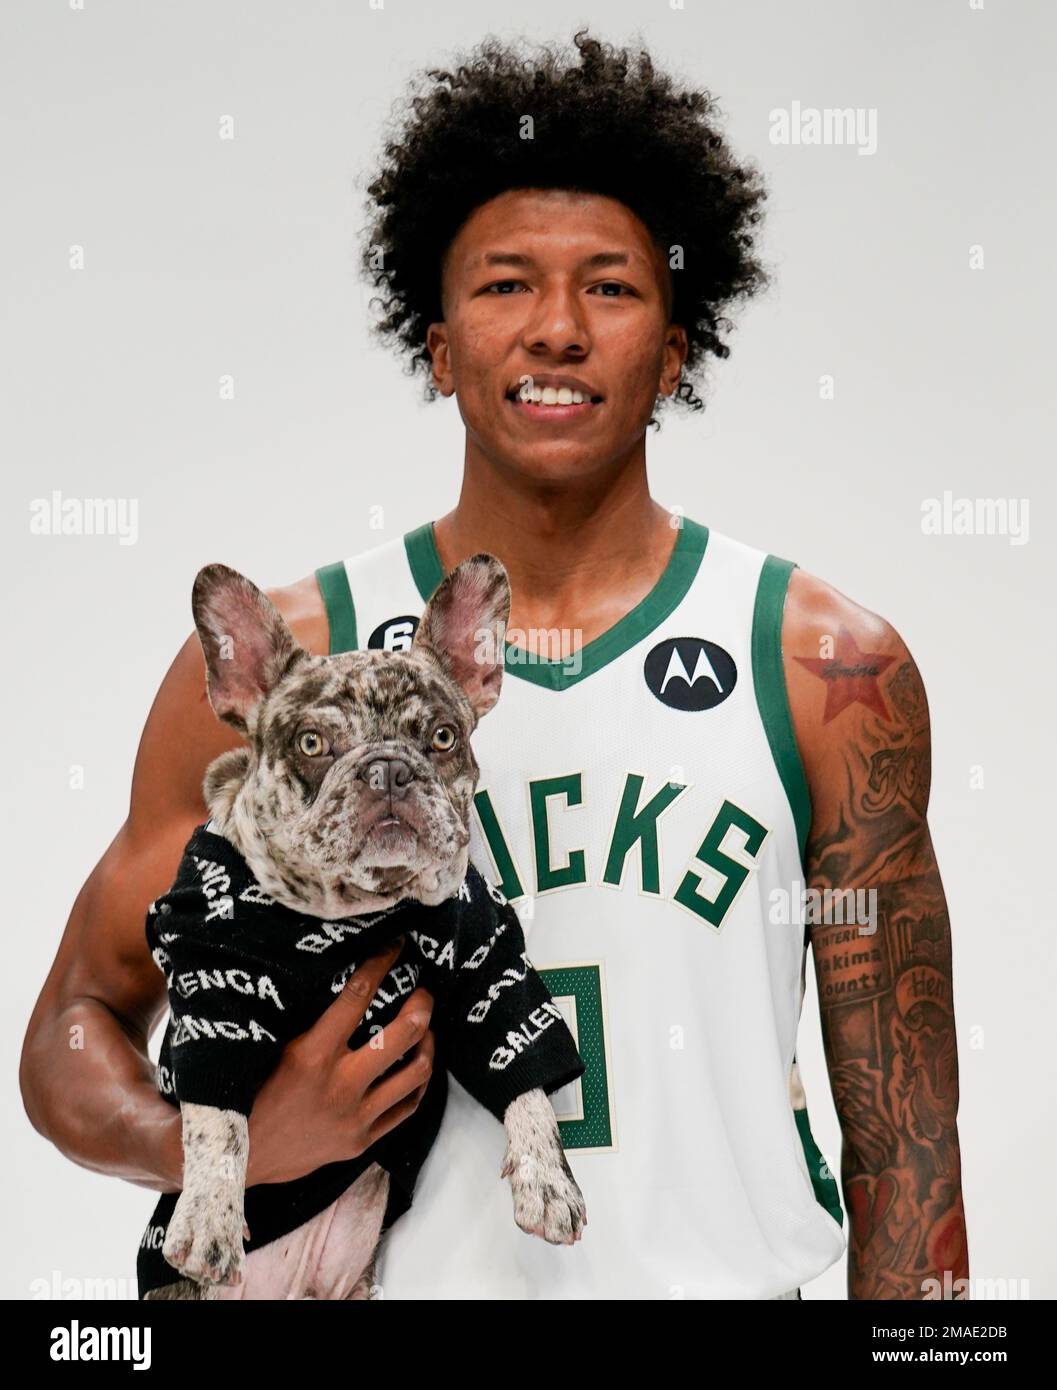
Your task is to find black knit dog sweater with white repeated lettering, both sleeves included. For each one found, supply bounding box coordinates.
[138,826,584,1298]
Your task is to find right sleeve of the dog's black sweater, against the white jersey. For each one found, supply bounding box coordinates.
[441,874,584,1120]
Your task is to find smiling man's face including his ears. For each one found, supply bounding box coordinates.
[427,189,687,480]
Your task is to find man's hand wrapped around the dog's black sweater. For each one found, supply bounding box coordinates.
[246,942,434,1187]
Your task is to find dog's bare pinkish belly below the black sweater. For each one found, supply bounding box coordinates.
[209,1163,389,1300]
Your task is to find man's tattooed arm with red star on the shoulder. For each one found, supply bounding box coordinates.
[782,570,968,1300]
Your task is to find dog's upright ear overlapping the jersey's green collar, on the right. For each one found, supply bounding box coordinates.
[412,553,510,719]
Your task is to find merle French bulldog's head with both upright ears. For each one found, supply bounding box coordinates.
[192,555,510,919]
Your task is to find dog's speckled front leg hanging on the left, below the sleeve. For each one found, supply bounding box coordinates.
[161,1104,249,1284]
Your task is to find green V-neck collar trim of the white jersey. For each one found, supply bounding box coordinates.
[403,517,708,691]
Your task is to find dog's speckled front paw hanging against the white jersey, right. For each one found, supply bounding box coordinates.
[499,1090,587,1245]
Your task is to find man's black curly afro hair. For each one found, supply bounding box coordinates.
[362,31,768,410]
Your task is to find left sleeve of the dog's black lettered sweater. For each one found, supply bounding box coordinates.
[147,894,288,1116]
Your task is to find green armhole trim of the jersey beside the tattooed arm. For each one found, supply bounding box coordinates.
[752,555,811,865]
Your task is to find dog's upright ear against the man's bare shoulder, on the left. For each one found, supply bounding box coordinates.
[191,564,306,734]
